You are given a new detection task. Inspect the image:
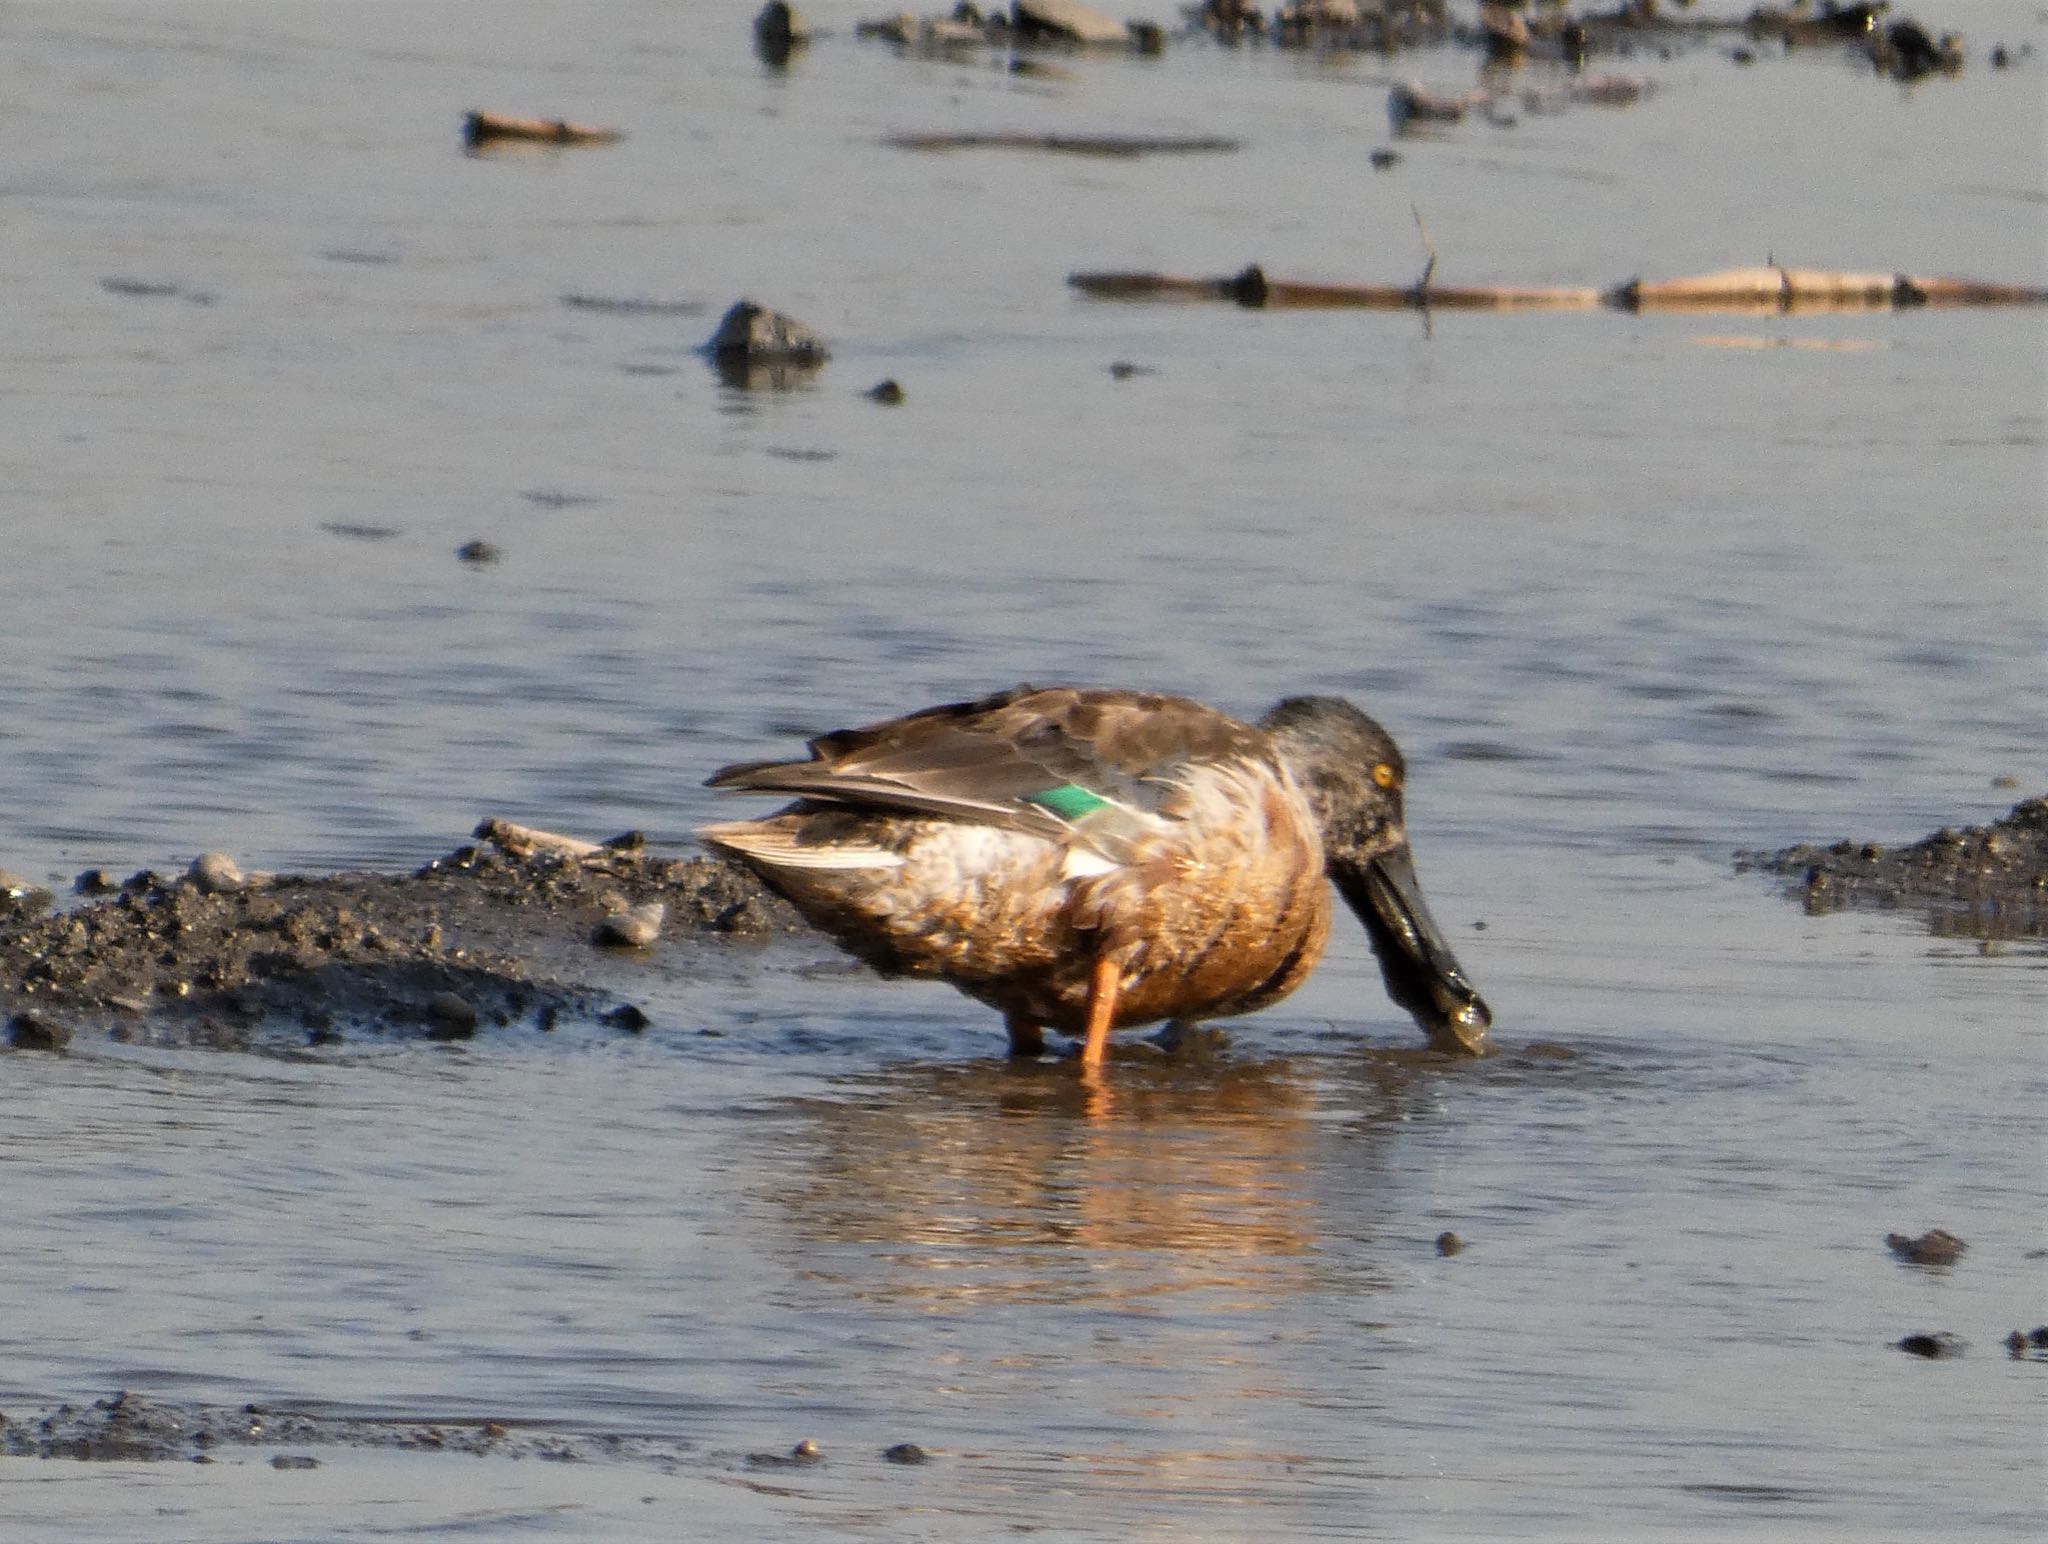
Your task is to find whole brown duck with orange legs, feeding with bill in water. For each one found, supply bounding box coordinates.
[698,686,1493,1069]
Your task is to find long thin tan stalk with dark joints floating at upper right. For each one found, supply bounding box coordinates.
[1067,264,2048,311]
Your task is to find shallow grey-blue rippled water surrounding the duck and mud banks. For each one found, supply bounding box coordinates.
[0,4,2048,1538]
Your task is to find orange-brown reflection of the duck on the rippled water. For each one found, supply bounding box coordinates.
[774,1055,1442,1313]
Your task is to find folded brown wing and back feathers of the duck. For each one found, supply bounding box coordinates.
[707,686,1266,835]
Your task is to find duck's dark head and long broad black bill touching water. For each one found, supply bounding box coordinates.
[1260,696,1493,1057]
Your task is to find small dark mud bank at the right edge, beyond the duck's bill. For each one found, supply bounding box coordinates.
[1735,799,2048,940]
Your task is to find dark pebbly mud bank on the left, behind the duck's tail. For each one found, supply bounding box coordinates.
[0,821,799,1048]
